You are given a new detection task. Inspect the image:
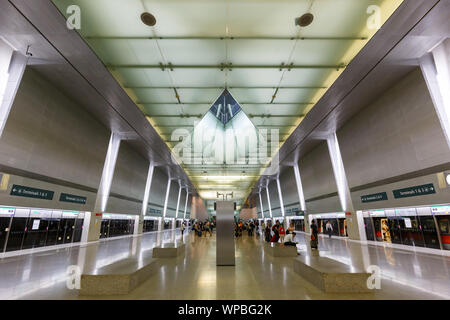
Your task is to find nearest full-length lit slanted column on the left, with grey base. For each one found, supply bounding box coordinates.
[88,132,120,241]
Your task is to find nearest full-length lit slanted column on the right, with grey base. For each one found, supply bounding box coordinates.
[327,133,361,240]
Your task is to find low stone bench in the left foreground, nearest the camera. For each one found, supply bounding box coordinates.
[79,254,160,296]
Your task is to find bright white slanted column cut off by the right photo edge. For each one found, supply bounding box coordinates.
[420,39,450,148]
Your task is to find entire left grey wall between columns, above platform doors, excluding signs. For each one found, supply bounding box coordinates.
[0,68,167,214]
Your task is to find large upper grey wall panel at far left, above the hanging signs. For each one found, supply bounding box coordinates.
[0,69,110,188]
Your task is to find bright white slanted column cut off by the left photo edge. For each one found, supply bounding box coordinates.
[0,49,28,138]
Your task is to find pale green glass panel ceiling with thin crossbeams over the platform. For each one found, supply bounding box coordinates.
[53,0,402,200]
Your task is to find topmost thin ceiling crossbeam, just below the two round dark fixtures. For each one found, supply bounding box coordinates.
[84,36,368,41]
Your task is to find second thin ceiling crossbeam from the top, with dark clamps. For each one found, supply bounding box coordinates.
[110,63,347,71]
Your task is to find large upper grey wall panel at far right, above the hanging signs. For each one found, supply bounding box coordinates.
[337,70,450,188]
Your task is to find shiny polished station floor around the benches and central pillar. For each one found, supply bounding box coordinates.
[0,231,450,299]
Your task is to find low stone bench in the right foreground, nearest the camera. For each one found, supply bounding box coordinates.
[294,255,373,293]
